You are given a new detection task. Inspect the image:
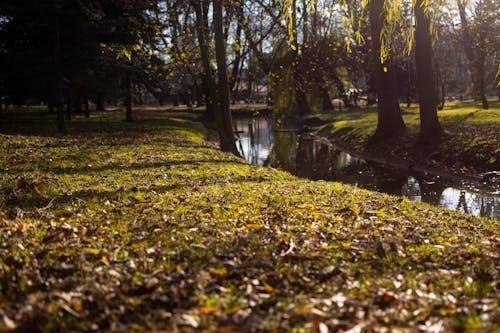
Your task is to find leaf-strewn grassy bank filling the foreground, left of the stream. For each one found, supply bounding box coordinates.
[0,110,500,332]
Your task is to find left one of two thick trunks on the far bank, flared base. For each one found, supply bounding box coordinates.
[369,0,406,142]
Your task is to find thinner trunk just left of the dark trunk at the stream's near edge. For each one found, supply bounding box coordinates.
[191,0,216,120]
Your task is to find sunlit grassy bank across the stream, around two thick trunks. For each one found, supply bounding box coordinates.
[308,101,500,175]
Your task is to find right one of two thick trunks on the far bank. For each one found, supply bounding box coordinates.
[414,0,442,145]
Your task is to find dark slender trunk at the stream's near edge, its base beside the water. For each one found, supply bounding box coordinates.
[214,0,239,156]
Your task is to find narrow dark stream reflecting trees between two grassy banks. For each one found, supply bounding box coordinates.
[235,118,500,219]
